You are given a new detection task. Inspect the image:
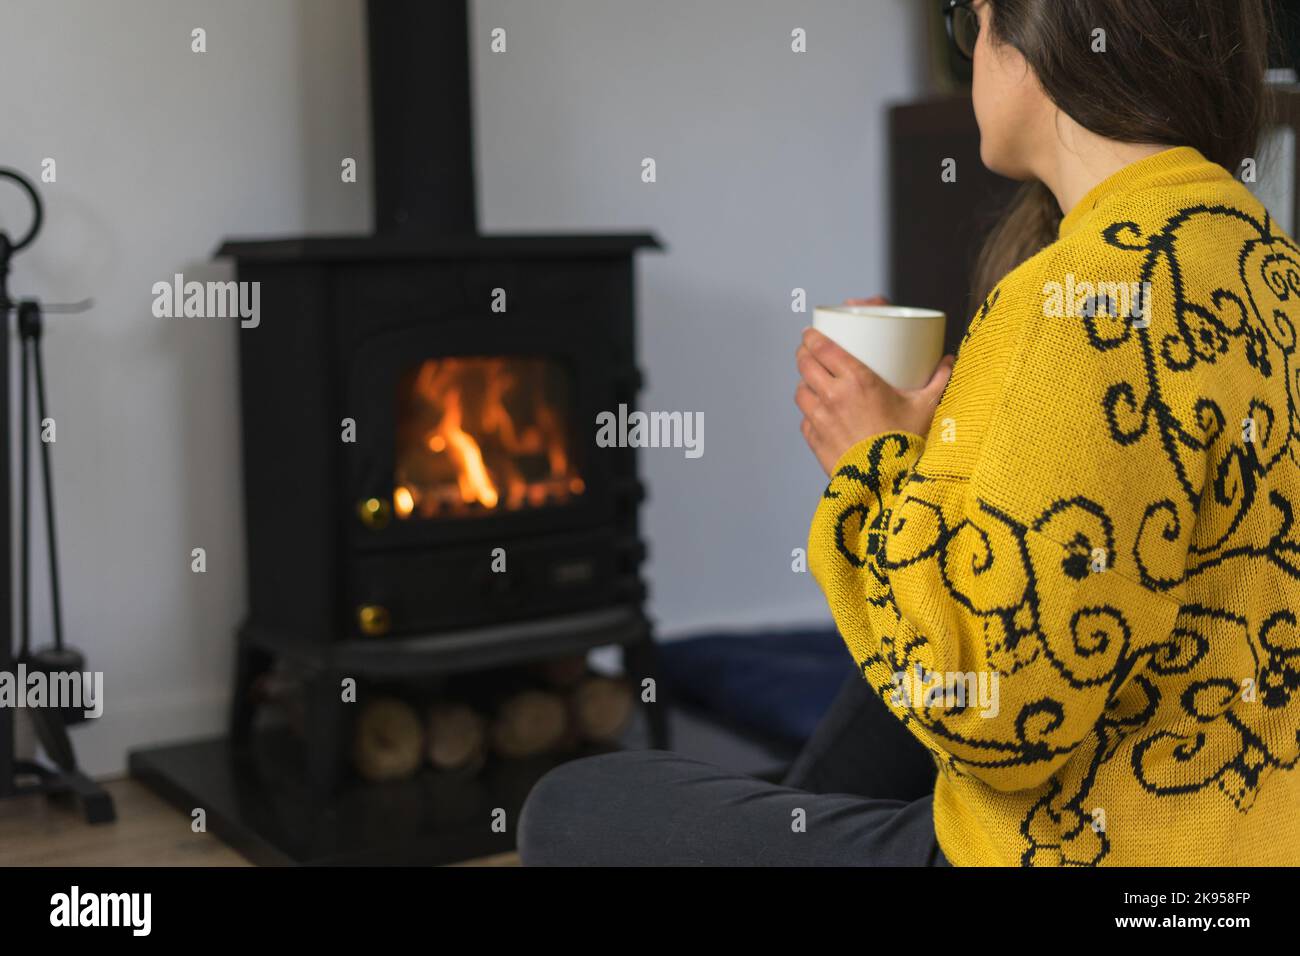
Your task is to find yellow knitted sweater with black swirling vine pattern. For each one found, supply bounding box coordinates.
[809,147,1300,866]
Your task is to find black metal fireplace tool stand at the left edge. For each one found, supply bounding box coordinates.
[0,168,116,823]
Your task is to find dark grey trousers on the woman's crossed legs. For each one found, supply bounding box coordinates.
[517,672,948,866]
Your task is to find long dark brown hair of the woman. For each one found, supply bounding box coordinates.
[975,0,1271,300]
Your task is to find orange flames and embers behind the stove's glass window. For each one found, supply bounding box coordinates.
[393,358,586,519]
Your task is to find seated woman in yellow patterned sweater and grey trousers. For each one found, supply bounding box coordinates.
[520,0,1300,865]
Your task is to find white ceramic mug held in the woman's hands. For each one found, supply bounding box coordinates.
[813,306,945,389]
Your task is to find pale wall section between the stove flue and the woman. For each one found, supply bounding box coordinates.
[473,0,924,635]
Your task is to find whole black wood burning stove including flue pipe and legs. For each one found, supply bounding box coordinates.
[133,0,667,861]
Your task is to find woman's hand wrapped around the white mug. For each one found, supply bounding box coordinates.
[794,327,956,475]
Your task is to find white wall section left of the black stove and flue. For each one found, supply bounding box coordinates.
[0,0,371,773]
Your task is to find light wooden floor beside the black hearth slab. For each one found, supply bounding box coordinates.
[0,778,519,866]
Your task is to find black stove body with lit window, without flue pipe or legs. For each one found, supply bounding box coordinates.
[222,237,653,649]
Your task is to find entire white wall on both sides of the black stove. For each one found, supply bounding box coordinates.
[0,0,922,773]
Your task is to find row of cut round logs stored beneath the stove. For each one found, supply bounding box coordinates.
[249,657,634,782]
